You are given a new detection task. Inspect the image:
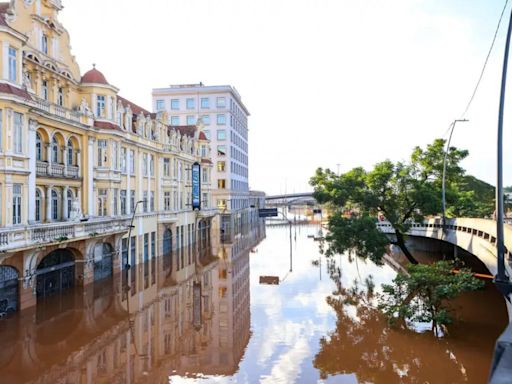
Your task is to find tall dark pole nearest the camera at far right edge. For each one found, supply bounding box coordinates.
[494,3,512,300]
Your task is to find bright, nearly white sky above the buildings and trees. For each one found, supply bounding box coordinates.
[60,0,512,194]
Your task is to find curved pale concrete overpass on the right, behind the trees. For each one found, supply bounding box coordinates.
[377,218,512,321]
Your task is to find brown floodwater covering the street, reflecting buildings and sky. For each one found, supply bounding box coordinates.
[0,226,507,384]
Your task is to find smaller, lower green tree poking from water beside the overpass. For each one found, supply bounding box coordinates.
[379,261,484,334]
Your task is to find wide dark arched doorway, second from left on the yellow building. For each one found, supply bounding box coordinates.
[36,249,75,298]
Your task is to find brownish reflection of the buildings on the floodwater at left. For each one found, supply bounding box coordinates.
[0,225,265,384]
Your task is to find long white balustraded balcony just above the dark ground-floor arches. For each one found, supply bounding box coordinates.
[0,218,130,252]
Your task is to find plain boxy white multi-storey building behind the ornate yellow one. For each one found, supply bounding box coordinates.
[152,83,250,242]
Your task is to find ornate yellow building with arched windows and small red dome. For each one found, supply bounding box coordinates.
[0,0,216,316]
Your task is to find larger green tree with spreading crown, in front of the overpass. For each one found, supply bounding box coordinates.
[310,139,468,264]
